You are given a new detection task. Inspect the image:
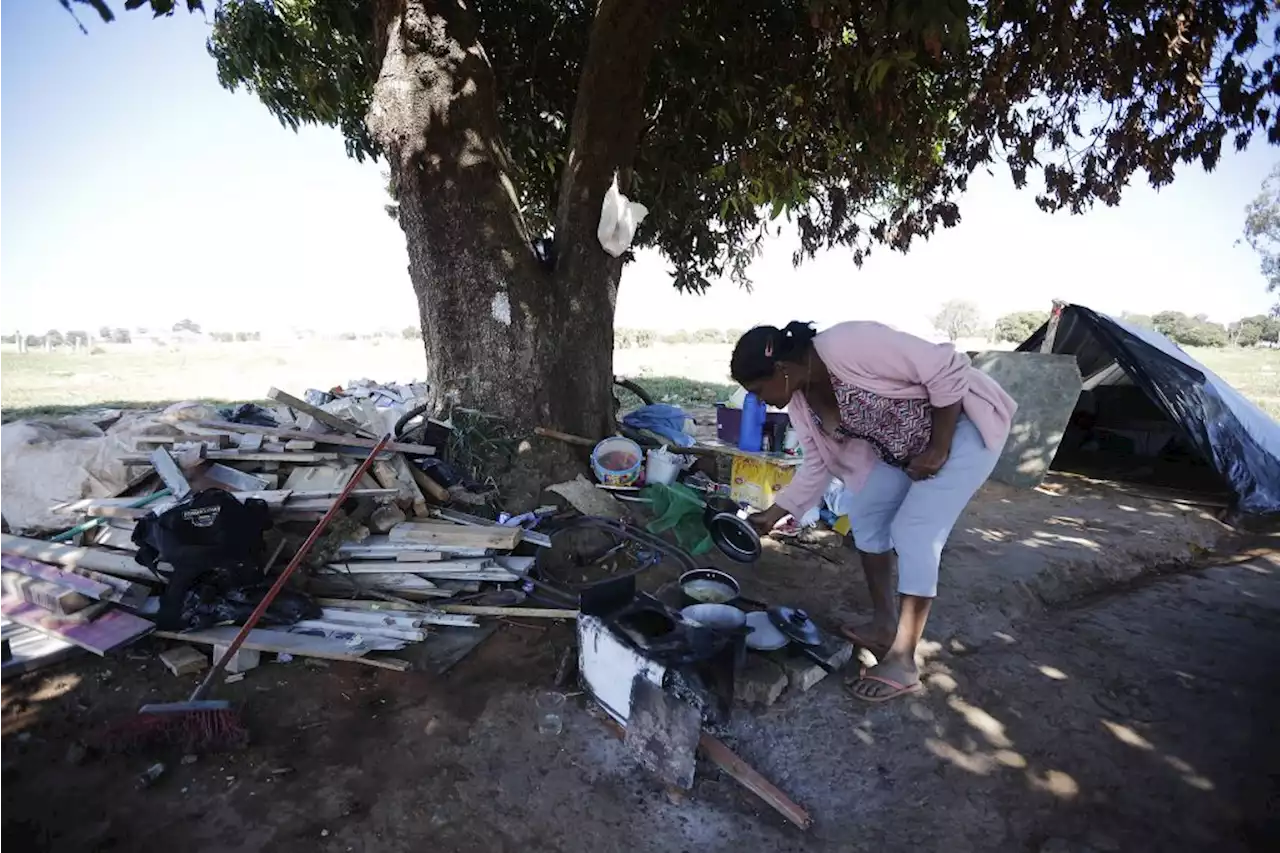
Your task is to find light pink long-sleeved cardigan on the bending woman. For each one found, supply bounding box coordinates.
[777,321,1018,517]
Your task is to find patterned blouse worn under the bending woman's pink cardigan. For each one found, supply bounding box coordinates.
[812,377,933,467]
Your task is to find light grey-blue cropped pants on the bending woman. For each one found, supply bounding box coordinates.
[849,415,1004,598]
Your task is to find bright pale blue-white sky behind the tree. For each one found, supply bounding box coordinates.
[0,0,1280,332]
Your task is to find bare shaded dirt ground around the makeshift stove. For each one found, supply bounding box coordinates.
[0,479,1280,853]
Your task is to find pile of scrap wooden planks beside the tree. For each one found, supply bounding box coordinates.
[0,387,575,669]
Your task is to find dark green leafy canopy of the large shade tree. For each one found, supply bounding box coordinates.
[80,0,1280,289]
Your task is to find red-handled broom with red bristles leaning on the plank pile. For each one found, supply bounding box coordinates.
[108,435,392,752]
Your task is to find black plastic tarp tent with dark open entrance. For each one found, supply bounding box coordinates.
[1019,305,1280,514]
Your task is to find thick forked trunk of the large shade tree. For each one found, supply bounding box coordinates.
[369,0,666,437]
